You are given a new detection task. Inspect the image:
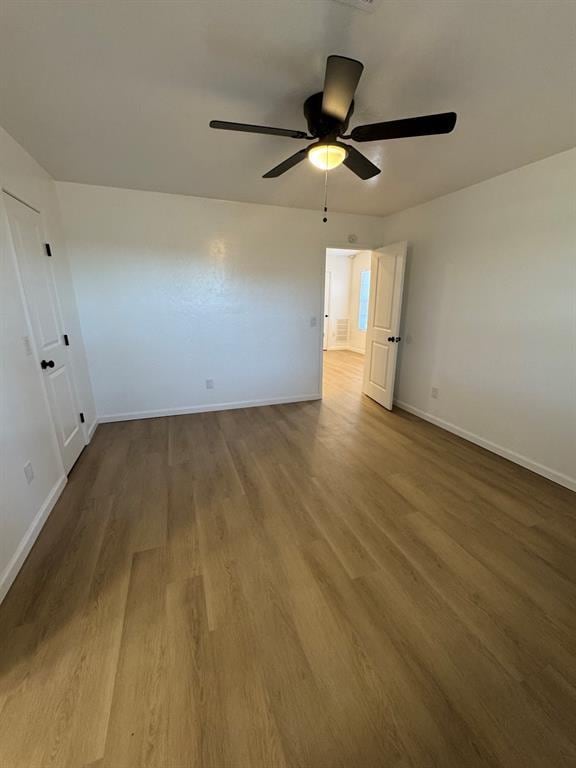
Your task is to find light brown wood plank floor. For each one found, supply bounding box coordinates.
[0,352,576,768]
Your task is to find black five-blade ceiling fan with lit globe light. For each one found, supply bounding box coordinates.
[210,56,456,179]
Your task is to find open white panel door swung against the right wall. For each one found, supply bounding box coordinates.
[363,243,408,410]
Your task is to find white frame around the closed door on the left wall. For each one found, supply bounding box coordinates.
[0,186,90,464]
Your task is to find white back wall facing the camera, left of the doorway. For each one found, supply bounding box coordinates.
[57,183,382,419]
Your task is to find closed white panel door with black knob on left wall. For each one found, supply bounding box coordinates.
[3,193,84,472]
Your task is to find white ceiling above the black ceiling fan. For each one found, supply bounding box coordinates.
[0,0,576,214]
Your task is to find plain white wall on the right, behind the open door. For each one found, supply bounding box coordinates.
[384,149,576,490]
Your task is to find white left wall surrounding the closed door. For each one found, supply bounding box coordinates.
[0,128,95,600]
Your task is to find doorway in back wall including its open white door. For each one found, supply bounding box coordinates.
[322,243,407,410]
